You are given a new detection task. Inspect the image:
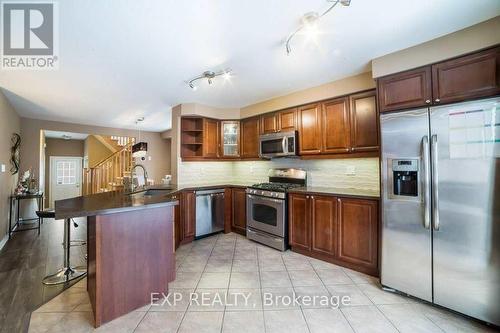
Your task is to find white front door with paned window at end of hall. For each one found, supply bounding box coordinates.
[49,156,82,208]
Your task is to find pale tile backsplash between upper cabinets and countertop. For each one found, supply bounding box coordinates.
[179,158,380,191]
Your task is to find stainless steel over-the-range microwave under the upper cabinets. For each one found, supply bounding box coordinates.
[259,131,297,158]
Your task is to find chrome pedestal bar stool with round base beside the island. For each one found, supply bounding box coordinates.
[36,210,87,285]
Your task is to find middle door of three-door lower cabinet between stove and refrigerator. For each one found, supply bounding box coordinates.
[310,195,337,256]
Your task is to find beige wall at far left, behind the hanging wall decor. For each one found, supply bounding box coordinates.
[0,91,20,237]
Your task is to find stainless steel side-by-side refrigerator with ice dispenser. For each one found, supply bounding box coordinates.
[380,98,500,325]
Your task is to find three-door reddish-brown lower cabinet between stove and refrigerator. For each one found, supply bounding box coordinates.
[288,193,378,276]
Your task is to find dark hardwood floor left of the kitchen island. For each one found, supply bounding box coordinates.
[0,219,87,333]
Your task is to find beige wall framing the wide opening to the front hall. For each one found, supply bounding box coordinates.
[21,118,170,184]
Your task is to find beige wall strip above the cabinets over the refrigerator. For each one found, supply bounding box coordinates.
[372,16,500,77]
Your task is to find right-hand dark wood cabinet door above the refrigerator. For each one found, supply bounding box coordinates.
[432,47,500,104]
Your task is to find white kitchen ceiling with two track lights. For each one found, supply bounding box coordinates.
[0,0,500,131]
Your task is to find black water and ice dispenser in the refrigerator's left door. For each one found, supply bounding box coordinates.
[392,159,419,197]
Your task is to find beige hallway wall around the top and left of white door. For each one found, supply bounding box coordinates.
[45,138,83,207]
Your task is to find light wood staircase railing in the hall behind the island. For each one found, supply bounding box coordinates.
[83,140,134,195]
